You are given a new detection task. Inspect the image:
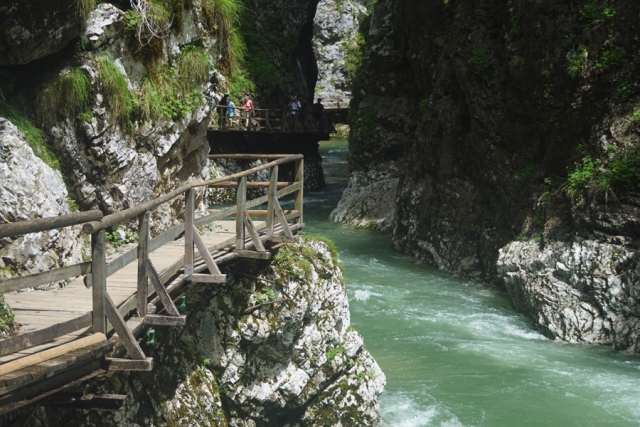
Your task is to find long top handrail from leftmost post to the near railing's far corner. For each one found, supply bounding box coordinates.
[82,154,304,234]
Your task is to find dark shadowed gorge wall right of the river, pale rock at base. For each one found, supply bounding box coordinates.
[340,0,640,351]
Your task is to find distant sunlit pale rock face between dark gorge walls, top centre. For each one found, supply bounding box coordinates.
[313,0,371,107]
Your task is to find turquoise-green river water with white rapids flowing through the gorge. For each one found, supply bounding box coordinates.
[305,141,640,427]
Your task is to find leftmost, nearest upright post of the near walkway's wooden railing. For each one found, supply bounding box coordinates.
[91,230,107,334]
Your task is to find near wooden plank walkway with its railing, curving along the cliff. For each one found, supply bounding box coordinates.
[0,154,304,414]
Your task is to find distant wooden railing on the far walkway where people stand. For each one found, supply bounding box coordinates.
[211,105,335,133]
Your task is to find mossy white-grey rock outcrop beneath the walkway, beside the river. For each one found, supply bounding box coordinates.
[25,238,386,427]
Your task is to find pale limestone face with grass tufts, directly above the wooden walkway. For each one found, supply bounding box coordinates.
[40,3,220,232]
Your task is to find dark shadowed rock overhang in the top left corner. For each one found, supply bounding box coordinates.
[0,0,88,65]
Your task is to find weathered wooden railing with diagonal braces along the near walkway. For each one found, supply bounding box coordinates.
[0,154,304,370]
